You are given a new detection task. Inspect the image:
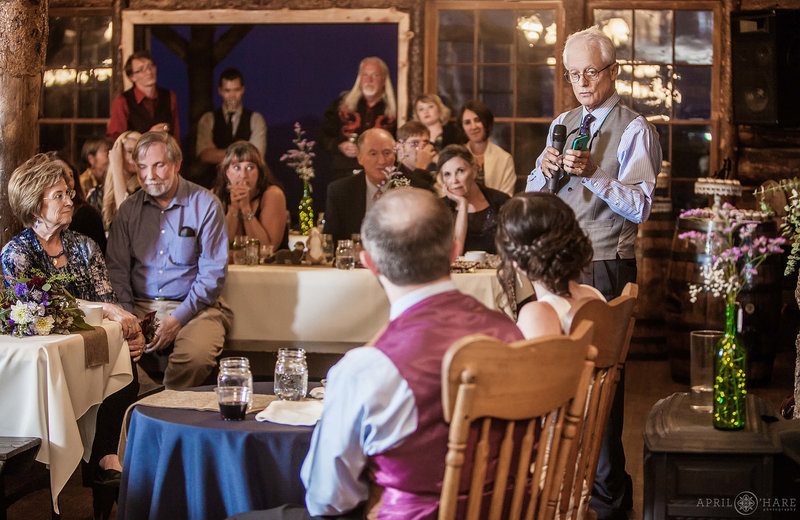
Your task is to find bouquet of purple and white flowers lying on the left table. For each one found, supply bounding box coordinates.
[0,270,92,337]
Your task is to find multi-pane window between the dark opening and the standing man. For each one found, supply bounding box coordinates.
[426,2,560,186]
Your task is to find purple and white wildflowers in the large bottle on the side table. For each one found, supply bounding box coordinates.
[678,203,786,305]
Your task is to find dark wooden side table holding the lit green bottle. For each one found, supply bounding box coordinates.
[644,393,783,520]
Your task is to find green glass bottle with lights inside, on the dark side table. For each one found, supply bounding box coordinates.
[714,302,747,430]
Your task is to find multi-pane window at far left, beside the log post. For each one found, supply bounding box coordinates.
[39,16,111,162]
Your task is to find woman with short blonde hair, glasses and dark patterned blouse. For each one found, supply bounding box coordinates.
[0,154,144,485]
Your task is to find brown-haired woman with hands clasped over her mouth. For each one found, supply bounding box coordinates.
[214,141,288,249]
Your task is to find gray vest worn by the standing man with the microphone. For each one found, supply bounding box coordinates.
[558,103,640,260]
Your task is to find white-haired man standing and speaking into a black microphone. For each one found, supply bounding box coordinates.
[527,27,661,519]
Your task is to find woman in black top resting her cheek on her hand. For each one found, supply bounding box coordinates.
[436,144,508,253]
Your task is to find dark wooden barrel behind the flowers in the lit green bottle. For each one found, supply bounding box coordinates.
[665,218,783,386]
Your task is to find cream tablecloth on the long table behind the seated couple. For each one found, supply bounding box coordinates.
[222,265,512,352]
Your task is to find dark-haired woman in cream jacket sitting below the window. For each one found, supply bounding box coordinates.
[458,99,517,196]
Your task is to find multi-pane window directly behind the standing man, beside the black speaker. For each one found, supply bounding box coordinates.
[593,9,718,209]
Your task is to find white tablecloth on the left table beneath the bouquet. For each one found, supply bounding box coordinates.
[0,320,133,512]
